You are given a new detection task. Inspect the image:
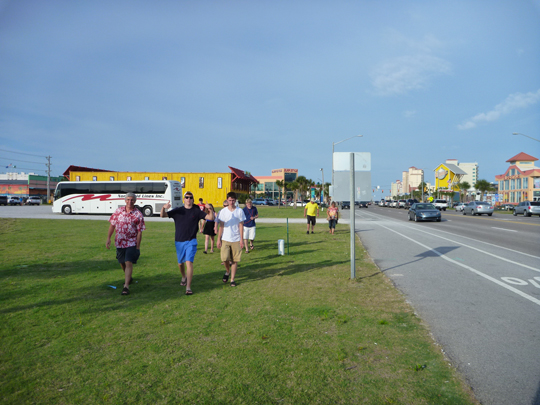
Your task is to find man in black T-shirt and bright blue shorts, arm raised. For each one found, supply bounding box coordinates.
[160,191,211,295]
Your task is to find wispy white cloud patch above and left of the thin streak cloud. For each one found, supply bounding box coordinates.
[371,55,451,96]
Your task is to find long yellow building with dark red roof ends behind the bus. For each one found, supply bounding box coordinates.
[66,166,258,206]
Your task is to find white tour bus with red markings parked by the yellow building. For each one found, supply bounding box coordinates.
[52,180,183,217]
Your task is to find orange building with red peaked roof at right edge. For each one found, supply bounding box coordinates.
[495,152,540,205]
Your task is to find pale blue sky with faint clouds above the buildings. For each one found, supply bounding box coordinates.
[0,0,540,197]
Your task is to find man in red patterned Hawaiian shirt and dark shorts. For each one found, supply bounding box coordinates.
[105,193,146,295]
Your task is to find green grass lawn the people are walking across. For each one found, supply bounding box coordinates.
[0,219,476,404]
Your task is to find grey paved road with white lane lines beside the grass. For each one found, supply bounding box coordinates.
[343,207,540,405]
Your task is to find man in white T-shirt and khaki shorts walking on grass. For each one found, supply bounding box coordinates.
[217,191,246,287]
